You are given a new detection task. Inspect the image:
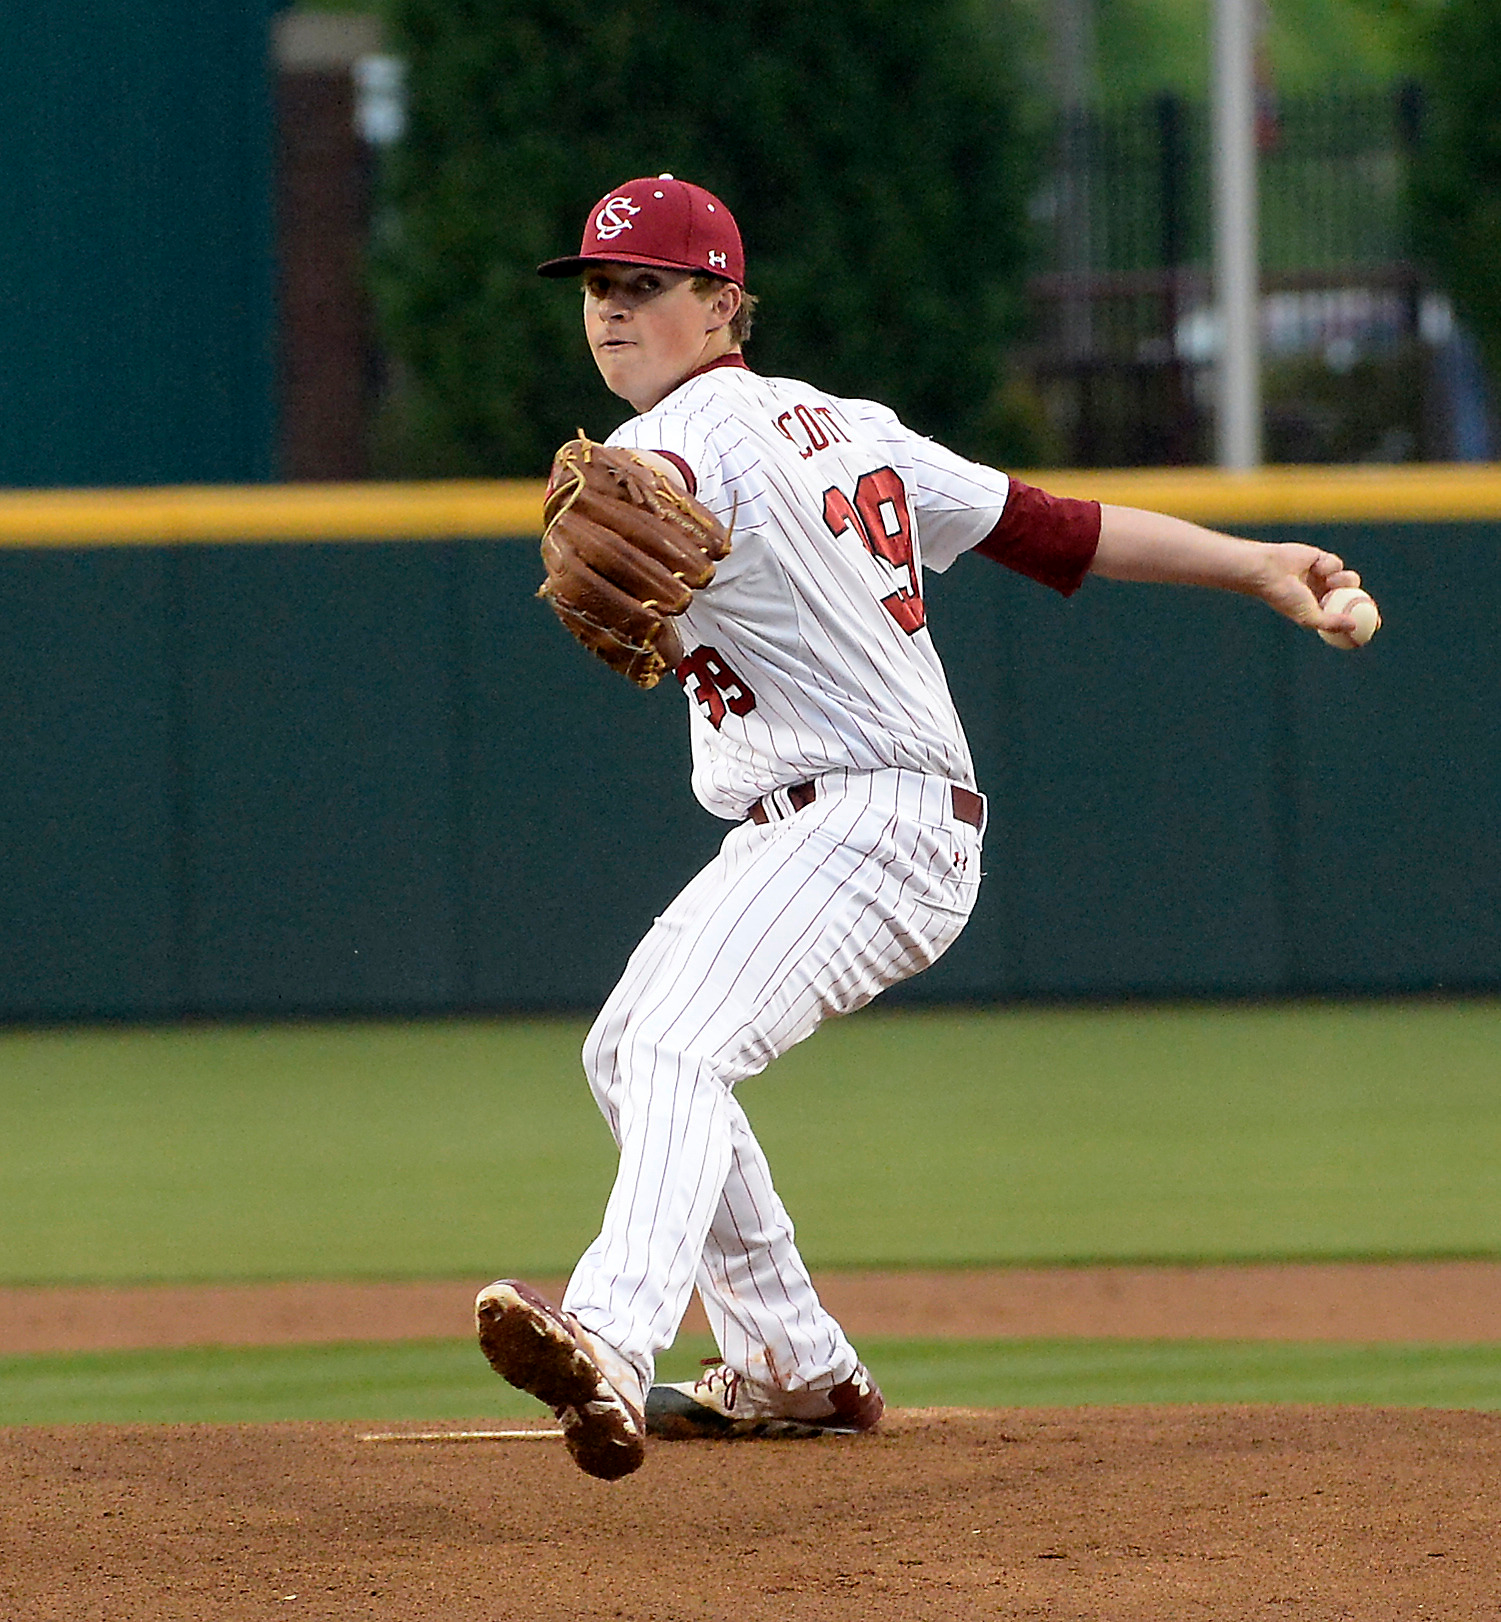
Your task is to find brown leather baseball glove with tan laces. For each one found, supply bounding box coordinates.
[537,430,730,688]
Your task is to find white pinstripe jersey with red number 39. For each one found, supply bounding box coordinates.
[610,366,1009,821]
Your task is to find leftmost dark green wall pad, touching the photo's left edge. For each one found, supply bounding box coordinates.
[0,550,185,1019]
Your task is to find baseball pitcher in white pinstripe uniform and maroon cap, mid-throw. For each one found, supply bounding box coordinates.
[477,175,1358,1479]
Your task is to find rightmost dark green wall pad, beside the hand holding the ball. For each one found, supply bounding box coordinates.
[1280,524,1501,991]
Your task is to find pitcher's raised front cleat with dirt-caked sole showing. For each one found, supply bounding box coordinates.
[474,1278,646,1481]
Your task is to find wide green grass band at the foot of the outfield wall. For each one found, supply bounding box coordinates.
[0,1001,1501,1283]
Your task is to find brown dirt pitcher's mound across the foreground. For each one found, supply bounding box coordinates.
[0,1408,1501,1622]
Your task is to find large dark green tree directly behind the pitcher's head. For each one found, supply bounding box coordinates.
[375,0,1042,475]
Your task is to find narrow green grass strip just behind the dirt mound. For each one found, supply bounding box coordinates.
[0,1340,1501,1426]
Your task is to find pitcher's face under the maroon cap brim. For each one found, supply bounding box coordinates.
[584,264,738,410]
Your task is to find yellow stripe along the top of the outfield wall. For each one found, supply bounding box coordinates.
[0,464,1501,547]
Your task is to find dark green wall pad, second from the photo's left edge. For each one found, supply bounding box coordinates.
[177,545,462,1012]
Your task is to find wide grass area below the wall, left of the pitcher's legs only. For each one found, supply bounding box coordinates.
[0,1022,613,1281]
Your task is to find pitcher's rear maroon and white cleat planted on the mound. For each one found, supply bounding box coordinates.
[646,1362,886,1442]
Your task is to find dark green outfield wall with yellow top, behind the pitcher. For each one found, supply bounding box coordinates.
[0,469,1501,1020]
